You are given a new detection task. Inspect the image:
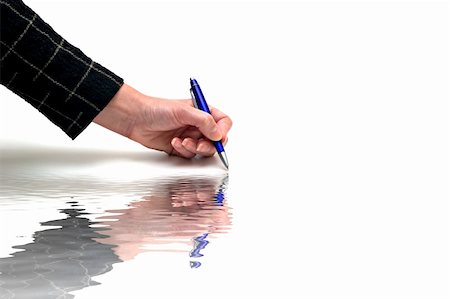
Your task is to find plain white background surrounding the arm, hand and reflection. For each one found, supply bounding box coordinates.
[0,0,450,298]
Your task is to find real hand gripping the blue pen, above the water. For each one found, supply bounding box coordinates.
[94,84,232,158]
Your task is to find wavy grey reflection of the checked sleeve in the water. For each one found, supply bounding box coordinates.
[0,209,122,299]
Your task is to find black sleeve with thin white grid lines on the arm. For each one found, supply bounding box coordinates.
[0,0,123,139]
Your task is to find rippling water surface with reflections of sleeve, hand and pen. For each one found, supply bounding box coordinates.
[0,146,231,298]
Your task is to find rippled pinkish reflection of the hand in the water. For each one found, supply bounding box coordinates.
[98,178,231,260]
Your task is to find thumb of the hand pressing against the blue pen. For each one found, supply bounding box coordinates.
[181,107,222,141]
